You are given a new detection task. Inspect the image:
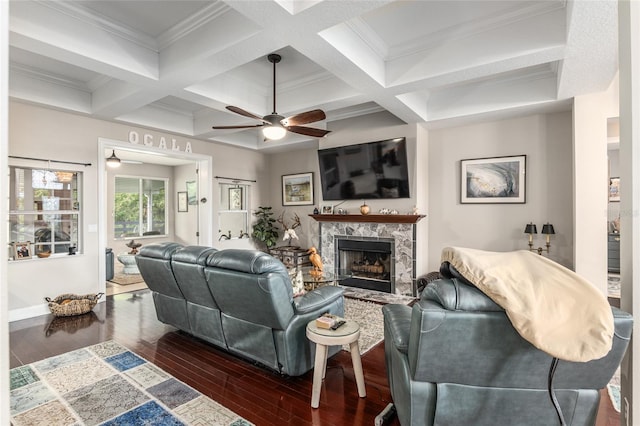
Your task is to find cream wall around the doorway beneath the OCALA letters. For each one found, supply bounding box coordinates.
[10,102,270,321]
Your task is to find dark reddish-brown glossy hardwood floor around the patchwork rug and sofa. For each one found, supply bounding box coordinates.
[10,290,620,426]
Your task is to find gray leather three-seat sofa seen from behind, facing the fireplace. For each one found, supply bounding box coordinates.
[136,243,344,376]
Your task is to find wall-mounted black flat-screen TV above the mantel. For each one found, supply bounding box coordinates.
[318,138,409,200]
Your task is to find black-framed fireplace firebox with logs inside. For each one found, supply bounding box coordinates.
[335,236,395,293]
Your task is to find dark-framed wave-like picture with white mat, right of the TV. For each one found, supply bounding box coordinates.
[460,155,527,204]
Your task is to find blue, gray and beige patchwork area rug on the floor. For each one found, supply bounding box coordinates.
[10,341,251,426]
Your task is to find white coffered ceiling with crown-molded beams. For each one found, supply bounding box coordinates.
[9,0,617,152]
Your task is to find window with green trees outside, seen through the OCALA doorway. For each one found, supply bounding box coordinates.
[113,176,168,238]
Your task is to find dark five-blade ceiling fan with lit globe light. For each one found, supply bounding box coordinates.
[212,53,330,140]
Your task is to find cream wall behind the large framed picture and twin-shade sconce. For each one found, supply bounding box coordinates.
[428,113,573,270]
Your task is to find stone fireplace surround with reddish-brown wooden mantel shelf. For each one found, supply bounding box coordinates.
[310,215,424,297]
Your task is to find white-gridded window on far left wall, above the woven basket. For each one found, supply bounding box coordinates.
[9,166,82,257]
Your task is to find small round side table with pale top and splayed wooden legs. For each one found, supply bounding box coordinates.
[307,320,367,408]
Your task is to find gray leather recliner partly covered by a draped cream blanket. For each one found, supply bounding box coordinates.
[382,264,633,426]
